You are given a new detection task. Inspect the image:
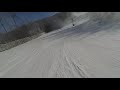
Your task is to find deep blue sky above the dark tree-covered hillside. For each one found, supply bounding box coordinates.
[0,12,56,33]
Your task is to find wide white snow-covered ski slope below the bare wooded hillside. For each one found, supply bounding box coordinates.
[0,13,120,78]
